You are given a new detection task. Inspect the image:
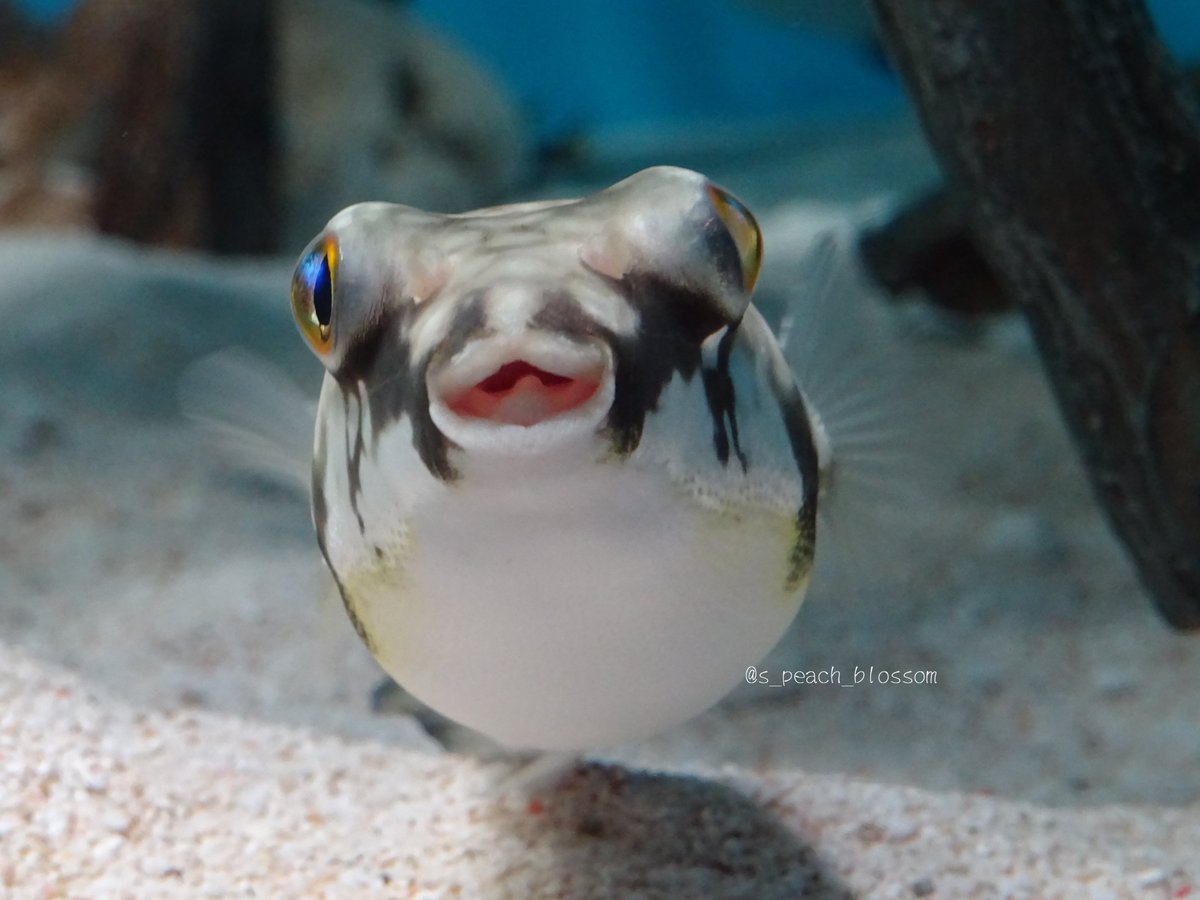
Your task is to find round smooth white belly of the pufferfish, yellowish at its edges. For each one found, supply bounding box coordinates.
[344,463,804,750]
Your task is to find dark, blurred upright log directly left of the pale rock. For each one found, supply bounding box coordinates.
[87,0,280,253]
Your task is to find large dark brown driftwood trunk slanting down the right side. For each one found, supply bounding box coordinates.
[871,0,1200,629]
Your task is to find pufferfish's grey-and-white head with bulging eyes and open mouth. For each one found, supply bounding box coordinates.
[292,167,761,468]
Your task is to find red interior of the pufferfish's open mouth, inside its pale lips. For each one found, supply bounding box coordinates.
[446,360,600,427]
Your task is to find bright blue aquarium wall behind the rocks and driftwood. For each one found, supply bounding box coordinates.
[17,0,1200,136]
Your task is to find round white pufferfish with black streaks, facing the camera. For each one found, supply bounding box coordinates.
[292,167,827,751]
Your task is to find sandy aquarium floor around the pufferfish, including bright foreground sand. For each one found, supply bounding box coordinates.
[0,118,1200,898]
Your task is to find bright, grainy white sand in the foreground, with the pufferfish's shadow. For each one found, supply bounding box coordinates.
[0,650,1200,898]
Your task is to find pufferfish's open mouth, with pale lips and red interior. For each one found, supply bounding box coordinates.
[426,334,612,441]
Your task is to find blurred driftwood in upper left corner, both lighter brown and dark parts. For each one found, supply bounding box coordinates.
[0,0,281,253]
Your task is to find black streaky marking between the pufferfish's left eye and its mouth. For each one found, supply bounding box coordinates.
[334,296,458,482]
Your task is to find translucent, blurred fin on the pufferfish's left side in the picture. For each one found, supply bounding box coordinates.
[179,347,317,496]
